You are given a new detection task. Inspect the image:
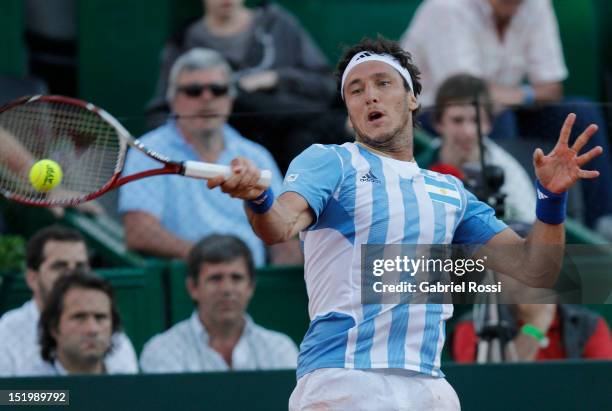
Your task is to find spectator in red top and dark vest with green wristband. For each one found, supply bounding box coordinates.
[452,304,612,363]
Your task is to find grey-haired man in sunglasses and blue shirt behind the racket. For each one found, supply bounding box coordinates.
[119,49,301,266]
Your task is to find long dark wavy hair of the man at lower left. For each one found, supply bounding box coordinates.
[38,271,121,362]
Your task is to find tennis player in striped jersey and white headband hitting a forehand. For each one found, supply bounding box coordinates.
[208,38,602,410]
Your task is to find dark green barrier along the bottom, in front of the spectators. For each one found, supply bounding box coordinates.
[0,361,612,411]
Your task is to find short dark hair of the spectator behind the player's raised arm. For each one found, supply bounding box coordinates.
[433,74,493,123]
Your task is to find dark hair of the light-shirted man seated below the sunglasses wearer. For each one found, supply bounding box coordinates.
[187,234,255,283]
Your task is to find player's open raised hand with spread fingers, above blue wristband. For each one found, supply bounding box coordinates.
[533,113,603,193]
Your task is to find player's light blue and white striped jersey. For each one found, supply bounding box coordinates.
[283,143,506,378]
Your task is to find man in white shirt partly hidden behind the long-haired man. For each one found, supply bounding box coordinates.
[0,226,138,377]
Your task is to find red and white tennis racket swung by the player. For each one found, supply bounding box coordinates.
[0,96,272,207]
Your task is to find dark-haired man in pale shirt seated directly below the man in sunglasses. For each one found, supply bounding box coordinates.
[140,235,297,373]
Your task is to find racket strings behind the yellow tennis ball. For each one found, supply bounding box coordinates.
[0,99,122,205]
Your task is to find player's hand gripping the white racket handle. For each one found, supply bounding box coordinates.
[206,157,266,200]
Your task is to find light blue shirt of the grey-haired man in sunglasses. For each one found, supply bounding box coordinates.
[119,121,282,266]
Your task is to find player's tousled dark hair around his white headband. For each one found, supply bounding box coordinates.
[336,34,422,97]
